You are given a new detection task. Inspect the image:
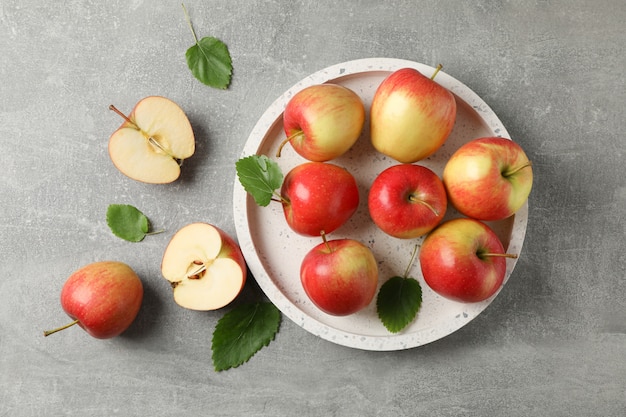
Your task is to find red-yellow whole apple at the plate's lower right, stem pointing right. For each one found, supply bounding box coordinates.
[419,218,514,302]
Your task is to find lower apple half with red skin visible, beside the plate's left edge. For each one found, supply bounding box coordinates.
[161,223,247,311]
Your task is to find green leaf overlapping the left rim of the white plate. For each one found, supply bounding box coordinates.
[235,155,283,207]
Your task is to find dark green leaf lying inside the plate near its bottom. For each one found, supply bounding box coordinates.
[376,276,422,333]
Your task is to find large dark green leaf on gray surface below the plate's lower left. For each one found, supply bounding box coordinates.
[211,302,281,372]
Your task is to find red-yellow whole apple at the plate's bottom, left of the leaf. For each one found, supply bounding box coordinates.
[300,239,378,316]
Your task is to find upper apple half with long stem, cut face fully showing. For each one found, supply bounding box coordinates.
[109,96,195,184]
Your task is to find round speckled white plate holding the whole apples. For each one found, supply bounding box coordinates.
[233,58,528,351]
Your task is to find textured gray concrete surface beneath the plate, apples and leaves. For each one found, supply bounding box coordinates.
[0,0,626,417]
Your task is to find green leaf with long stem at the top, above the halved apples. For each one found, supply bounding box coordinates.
[183,5,233,90]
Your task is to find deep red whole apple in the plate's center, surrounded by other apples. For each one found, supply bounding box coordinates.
[368,164,448,239]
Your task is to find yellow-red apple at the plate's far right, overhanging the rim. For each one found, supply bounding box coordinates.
[443,137,533,221]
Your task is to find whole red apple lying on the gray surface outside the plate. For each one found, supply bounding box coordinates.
[44,261,143,339]
